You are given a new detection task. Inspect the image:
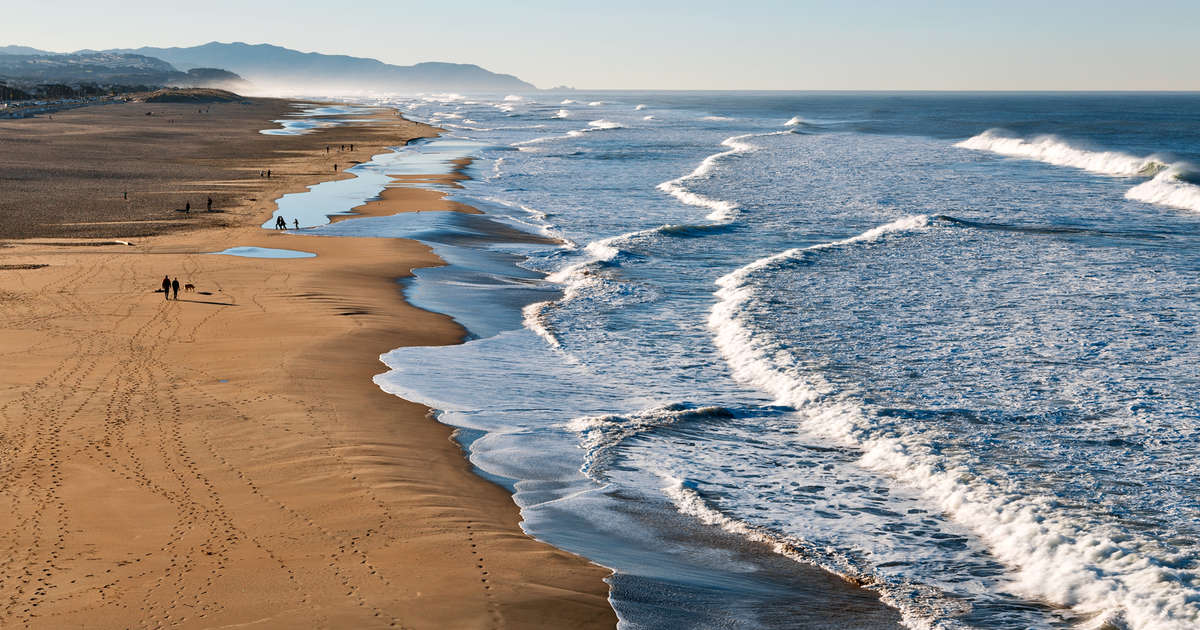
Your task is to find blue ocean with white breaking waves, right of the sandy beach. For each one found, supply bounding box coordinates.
[278,92,1200,629]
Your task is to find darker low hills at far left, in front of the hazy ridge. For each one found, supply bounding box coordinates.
[0,51,244,88]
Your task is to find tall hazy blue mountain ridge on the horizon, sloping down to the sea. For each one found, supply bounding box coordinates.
[106,42,536,91]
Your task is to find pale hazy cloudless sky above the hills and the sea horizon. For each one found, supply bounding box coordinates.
[0,0,1200,90]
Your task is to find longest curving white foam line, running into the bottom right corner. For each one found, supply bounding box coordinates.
[708,216,1200,630]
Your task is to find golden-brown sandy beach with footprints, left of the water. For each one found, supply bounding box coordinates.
[0,100,616,628]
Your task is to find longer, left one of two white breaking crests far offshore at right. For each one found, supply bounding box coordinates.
[955,130,1168,176]
